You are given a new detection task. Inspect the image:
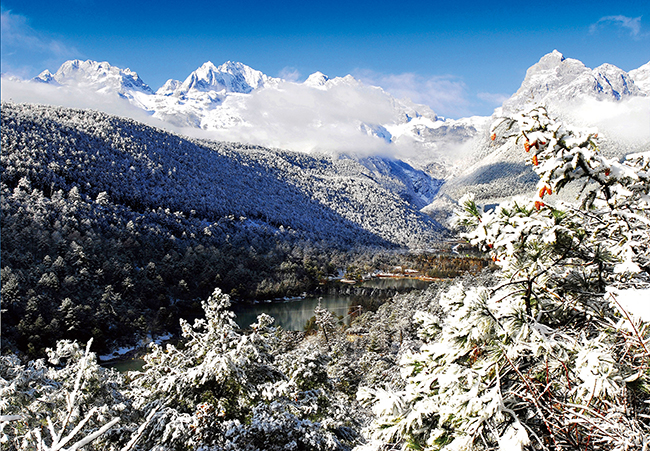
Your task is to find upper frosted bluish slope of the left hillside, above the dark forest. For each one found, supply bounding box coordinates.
[2,104,439,246]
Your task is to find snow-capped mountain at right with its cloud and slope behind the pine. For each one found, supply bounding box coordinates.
[436,50,650,213]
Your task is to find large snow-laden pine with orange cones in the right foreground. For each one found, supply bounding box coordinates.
[359,107,650,451]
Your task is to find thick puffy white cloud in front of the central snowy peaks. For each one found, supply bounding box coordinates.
[194,82,395,154]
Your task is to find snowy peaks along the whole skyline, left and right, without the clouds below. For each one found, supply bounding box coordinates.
[15,50,650,150]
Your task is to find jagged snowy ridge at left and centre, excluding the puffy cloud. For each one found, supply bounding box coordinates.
[22,60,450,154]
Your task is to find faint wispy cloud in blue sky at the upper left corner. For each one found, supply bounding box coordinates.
[1,9,80,77]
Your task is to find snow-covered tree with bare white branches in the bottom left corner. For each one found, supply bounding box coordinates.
[0,341,135,451]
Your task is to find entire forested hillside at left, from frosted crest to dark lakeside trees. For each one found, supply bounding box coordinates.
[1,103,440,354]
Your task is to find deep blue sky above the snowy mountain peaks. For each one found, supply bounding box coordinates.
[2,0,650,117]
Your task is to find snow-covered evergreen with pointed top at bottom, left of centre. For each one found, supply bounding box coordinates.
[131,289,357,450]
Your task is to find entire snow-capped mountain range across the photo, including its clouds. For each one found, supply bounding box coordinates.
[6,51,650,221]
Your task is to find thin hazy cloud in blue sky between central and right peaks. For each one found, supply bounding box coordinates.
[355,70,471,117]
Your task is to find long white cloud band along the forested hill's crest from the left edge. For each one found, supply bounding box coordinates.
[2,70,476,160]
